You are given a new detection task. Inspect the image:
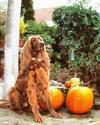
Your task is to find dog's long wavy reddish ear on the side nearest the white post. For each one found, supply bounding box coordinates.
[20,37,33,74]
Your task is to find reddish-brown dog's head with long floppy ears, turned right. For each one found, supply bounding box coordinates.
[20,35,48,72]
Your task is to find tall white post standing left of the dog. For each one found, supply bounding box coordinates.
[4,0,21,97]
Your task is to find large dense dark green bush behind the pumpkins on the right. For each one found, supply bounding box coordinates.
[53,4,100,73]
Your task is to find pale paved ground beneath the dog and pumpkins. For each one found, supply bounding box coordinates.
[0,108,100,125]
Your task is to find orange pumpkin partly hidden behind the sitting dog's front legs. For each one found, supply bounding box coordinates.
[39,88,64,110]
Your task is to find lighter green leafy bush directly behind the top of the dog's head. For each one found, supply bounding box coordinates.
[24,20,56,45]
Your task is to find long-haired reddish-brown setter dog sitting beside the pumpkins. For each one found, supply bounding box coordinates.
[9,35,60,122]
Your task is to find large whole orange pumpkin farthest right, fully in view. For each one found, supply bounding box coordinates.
[66,86,93,114]
